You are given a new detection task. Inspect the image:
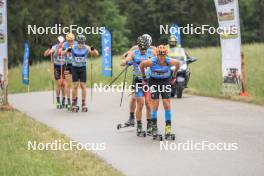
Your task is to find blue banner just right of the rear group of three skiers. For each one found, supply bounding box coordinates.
[102,29,112,77]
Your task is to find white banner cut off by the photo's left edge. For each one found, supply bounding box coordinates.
[0,0,8,75]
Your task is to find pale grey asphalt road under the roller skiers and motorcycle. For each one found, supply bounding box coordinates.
[9,92,264,176]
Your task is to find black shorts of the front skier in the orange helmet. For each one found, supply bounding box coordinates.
[149,78,171,99]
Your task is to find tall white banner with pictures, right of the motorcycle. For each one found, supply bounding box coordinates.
[214,0,242,92]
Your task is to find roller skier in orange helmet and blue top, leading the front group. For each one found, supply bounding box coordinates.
[140,45,180,138]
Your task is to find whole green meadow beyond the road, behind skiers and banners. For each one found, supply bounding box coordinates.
[9,44,264,104]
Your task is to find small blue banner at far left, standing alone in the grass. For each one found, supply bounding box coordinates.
[22,43,29,85]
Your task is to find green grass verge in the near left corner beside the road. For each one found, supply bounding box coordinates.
[0,111,121,176]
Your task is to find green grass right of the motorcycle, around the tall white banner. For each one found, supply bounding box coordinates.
[187,44,264,104]
